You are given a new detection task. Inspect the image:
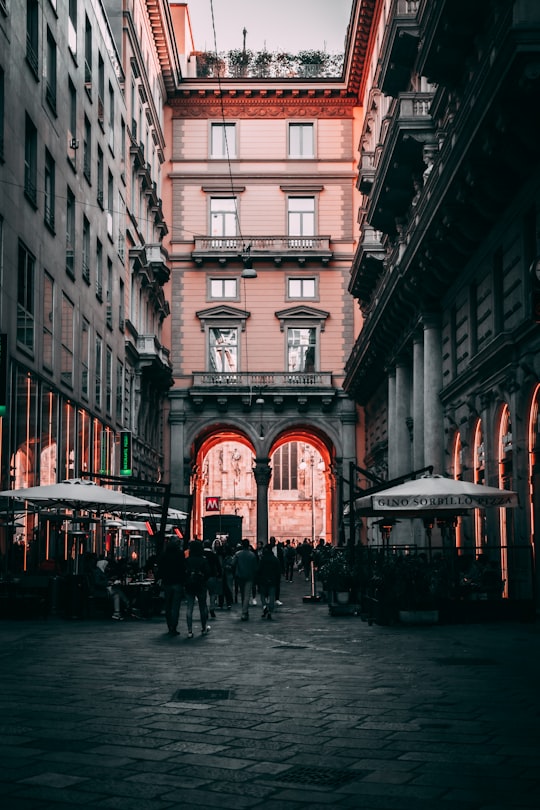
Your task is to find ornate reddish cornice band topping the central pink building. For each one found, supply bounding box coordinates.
[170,89,357,119]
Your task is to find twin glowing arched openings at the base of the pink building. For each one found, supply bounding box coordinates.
[192,428,335,545]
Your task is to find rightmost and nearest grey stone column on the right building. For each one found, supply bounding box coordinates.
[422,313,444,474]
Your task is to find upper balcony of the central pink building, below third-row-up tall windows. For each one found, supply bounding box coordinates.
[191,235,332,266]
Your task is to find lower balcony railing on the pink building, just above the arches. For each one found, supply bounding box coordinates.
[193,371,332,391]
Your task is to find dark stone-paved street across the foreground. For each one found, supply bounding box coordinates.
[0,582,540,810]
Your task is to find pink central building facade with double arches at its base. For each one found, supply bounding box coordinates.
[167,4,368,542]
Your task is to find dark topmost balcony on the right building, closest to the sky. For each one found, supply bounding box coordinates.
[378,0,419,98]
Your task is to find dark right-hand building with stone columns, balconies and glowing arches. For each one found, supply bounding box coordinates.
[344,0,540,598]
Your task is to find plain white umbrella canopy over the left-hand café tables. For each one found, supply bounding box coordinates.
[0,478,160,512]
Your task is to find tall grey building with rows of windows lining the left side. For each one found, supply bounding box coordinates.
[0,0,180,568]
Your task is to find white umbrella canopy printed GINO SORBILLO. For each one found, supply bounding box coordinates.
[354,475,519,517]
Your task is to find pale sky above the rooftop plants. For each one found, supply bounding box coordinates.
[187,0,352,53]
